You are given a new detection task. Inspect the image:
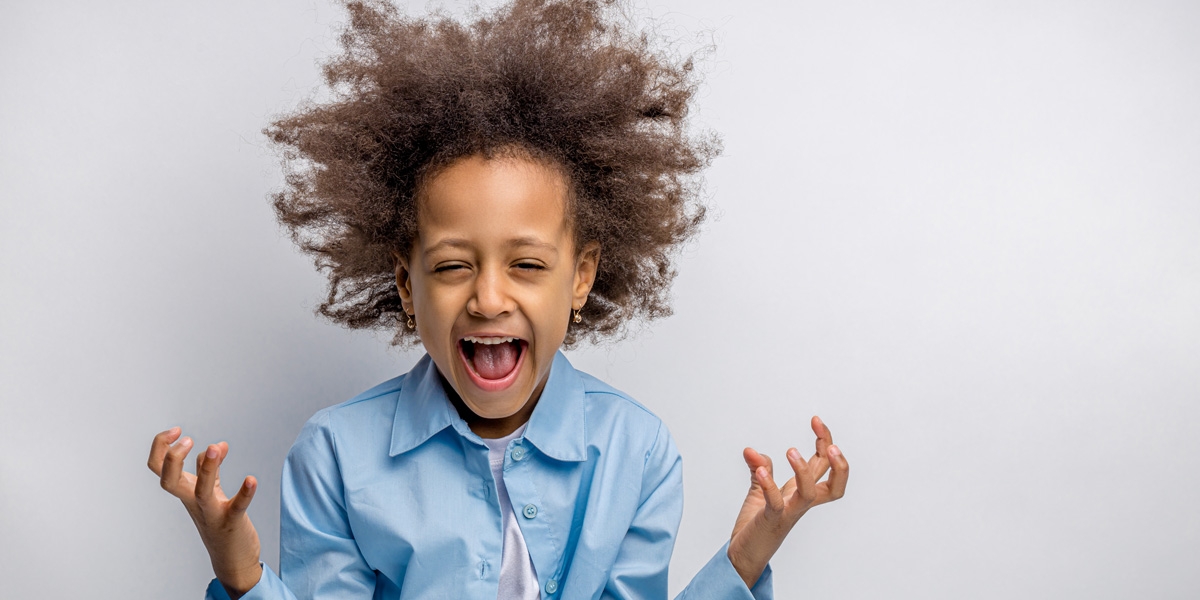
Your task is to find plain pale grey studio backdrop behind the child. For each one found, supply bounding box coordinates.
[0,0,1200,599]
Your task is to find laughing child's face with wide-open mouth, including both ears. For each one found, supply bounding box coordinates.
[396,156,599,437]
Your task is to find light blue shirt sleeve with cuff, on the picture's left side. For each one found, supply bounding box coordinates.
[205,410,376,600]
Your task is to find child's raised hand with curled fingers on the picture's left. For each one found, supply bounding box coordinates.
[146,427,263,599]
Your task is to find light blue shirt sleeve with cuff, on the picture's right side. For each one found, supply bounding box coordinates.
[601,424,774,600]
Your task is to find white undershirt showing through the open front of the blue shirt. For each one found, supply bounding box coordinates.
[481,424,541,600]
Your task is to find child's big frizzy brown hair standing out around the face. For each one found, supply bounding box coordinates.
[263,0,720,347]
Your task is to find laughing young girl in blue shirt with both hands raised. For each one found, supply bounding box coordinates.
[149,0,848,600]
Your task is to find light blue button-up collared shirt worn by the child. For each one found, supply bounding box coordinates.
[206,352,772,600]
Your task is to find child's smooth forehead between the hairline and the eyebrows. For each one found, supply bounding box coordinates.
[418,155,568,247]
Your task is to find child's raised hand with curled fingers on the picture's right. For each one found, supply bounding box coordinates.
[728,416,850,588]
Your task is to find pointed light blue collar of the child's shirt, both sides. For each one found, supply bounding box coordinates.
[388,352,587,461]
